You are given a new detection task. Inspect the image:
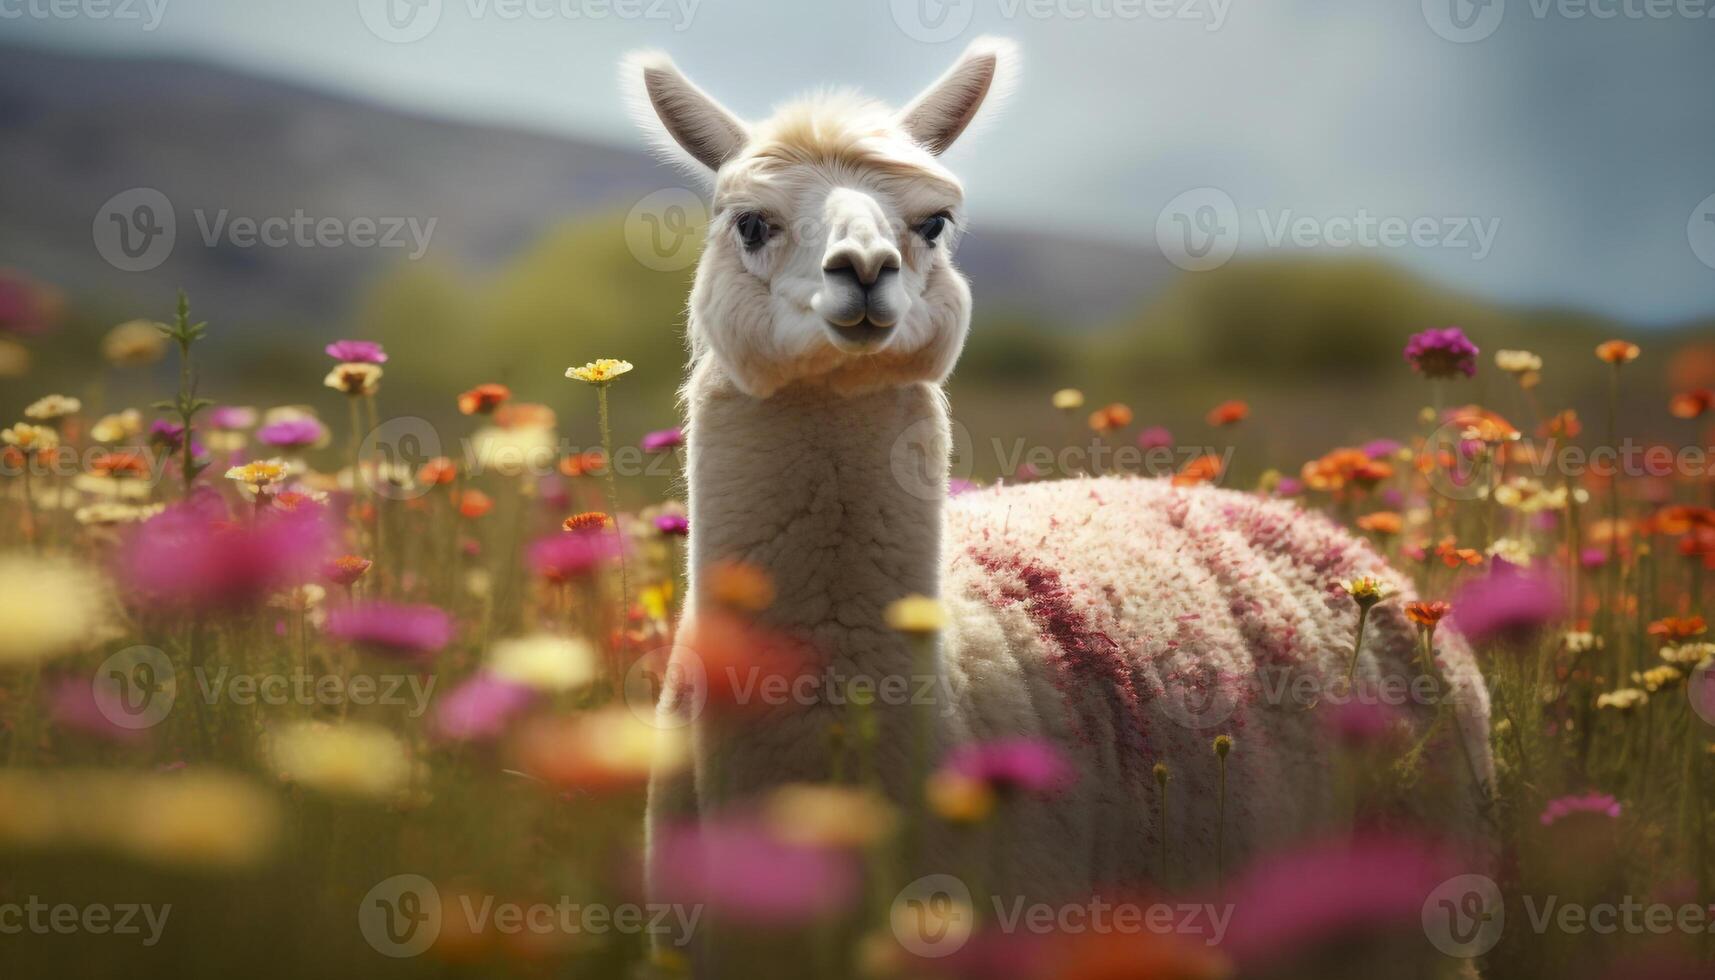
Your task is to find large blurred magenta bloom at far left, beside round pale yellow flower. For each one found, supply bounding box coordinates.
[117,496,334,611]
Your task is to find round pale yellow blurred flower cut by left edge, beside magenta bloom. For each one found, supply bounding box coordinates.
[0,554,106,668]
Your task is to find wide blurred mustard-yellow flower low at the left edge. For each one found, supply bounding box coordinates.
[0,769,281,868]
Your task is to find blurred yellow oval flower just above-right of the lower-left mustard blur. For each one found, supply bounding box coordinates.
[268,721,412,800]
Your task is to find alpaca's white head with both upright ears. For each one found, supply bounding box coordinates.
[624,39,1017,396]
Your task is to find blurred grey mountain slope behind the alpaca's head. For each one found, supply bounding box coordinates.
[0,46,1170,336]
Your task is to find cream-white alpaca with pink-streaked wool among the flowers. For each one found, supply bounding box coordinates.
[623,38,1494,919]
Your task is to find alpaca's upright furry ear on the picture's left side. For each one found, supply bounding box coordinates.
[619,51,749,170]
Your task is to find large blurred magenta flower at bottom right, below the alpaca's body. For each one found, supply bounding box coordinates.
[1223,836,1458,973]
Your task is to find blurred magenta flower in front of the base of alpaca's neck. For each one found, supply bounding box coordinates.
[652,819,859,925]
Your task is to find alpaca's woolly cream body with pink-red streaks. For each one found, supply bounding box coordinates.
[943,477,1494,894]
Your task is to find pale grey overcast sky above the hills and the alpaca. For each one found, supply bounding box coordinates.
[13,0,1715,321]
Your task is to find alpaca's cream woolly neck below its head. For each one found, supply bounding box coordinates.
[689,360,948,676]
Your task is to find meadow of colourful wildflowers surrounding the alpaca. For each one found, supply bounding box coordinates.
[0,266,1715,980]
